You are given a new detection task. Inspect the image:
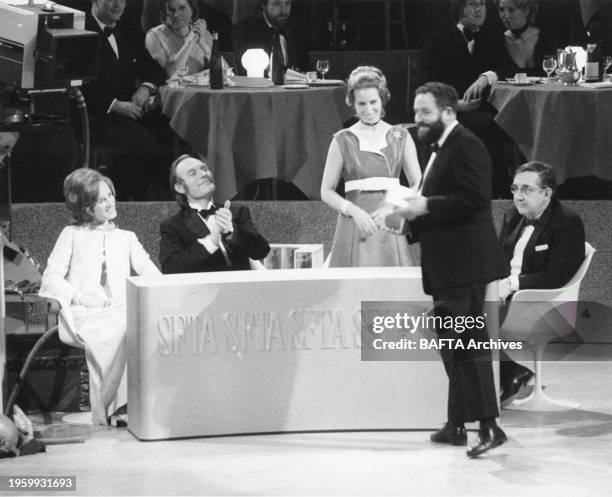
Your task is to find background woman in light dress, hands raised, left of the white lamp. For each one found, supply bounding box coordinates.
[145,0,222,77]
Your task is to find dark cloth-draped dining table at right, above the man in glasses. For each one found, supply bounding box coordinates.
[489,80,612,184]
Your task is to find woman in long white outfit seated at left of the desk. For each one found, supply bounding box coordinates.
[40,169,160,424]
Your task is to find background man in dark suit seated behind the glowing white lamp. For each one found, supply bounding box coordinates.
[233,0,310,75]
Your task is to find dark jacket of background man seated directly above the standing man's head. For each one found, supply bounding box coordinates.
[417,26,510,98]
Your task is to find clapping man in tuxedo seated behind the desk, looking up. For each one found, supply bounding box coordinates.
[159,154,270,273]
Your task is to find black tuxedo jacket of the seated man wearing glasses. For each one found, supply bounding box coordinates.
[500,198,585,289]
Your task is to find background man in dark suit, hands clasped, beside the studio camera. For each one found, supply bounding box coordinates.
[83,0,173,198]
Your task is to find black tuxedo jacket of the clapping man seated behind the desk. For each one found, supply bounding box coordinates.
[159,205,270,274]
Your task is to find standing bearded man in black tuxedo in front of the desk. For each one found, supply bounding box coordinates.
[374,83,507,457]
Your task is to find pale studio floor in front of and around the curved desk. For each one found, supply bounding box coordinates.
[0,361,612,497]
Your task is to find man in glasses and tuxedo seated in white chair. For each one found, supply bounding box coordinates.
[498,162,585,405]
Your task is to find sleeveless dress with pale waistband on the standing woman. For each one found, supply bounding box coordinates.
[329,126,414,267]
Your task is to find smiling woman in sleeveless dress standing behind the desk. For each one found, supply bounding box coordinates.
[321,66,421,267]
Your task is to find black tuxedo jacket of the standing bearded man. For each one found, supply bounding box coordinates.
[411,124,508,294]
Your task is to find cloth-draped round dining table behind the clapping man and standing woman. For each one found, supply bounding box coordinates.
[160,82,352,201]
